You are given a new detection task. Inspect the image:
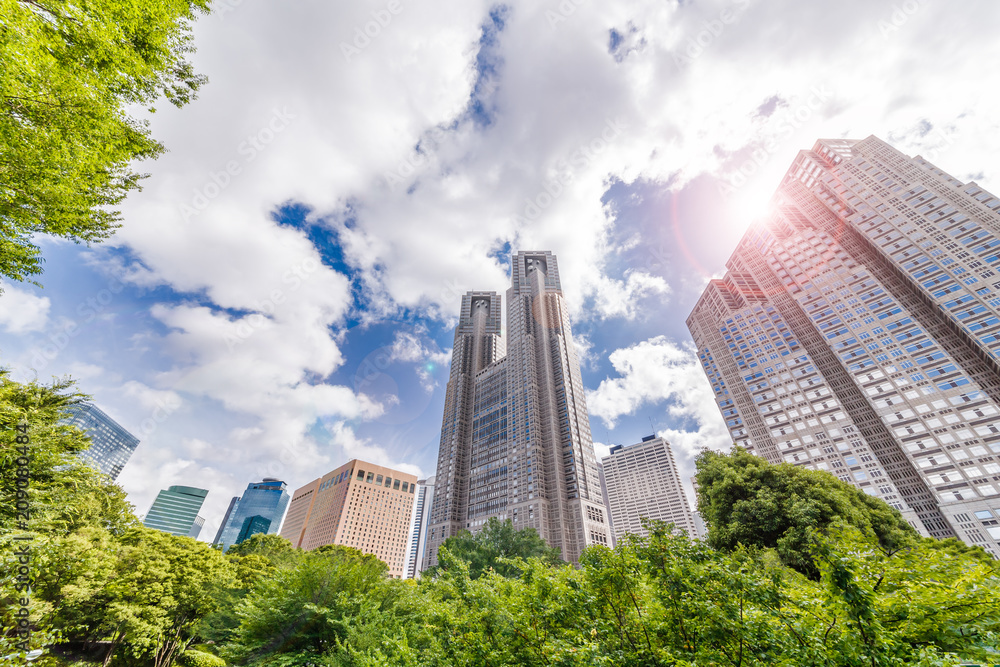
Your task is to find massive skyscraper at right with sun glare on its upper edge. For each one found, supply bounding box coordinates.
[688,137,1000,556]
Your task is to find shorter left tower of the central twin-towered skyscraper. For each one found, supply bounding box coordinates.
[422,292,501,569]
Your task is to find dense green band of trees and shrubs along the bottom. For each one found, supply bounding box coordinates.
[0,377,1000,667]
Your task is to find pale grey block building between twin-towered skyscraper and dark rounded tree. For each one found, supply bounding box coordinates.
[601,435,698,540]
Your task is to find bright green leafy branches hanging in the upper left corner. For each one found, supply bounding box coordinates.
[0,0,209,280]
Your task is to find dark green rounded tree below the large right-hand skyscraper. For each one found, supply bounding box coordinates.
[696,447,920,579]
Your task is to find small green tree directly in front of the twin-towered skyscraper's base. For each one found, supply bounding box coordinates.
[426,517,562,579]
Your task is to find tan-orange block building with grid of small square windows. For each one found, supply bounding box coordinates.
[280,460,417,578]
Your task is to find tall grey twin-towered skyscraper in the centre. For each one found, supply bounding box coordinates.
[424,252,609,569]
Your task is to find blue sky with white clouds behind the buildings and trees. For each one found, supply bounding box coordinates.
[0,0,1000,540]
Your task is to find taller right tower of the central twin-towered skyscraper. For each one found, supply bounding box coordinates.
[507,252,610,562]
